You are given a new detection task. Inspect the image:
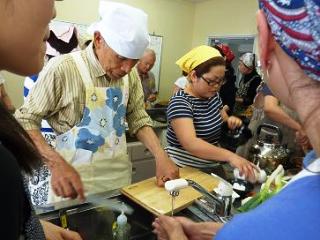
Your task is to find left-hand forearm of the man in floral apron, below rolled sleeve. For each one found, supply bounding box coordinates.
[27,129,63,169]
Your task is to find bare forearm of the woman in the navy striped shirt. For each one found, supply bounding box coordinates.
[183,138,234,162]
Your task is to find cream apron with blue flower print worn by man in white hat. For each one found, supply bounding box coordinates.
[35,52,132,203]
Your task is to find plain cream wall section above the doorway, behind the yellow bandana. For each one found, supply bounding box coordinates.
[192,0,258,47]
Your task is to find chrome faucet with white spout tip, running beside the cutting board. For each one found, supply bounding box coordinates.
[165,178,232,217]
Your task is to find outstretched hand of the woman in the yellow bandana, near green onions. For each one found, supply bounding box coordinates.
[229,154,259,182]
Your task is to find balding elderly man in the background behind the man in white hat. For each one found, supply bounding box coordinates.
[137,48,157,102]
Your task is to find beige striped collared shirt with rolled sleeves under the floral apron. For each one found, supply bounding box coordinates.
[15,44,152,134]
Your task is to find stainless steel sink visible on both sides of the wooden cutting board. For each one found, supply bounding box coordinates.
[36,189,232,240]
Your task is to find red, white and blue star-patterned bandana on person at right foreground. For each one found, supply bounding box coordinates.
[259,0,320,81]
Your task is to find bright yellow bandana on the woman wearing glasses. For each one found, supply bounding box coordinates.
[176,45,222,73]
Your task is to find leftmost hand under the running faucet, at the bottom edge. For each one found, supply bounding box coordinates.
[152,215,188,240]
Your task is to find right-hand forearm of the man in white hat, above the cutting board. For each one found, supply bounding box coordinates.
[136,126,166,160]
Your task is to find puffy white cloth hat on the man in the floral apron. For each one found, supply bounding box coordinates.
[88,1,150,59]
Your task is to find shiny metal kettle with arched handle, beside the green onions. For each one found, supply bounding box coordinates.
[249,123,290,174]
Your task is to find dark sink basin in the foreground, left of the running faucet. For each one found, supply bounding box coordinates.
[39,196,156,240]
